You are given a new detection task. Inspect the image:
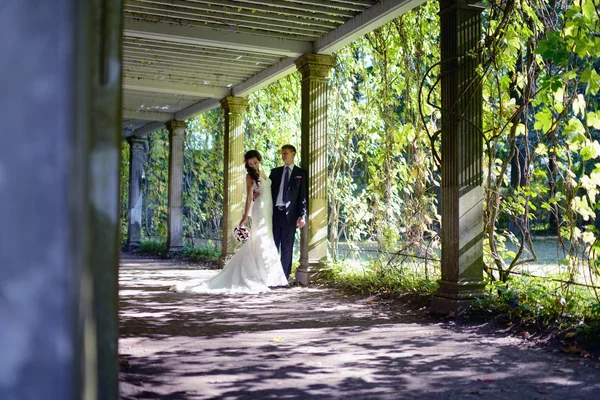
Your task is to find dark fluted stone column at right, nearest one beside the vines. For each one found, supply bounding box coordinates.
[432,0,485,315]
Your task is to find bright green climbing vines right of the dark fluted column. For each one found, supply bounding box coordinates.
[468,0,600,281]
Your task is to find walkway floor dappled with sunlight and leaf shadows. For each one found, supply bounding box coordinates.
[120,256,600,399]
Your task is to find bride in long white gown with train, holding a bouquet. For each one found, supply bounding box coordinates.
[175,150,288,294]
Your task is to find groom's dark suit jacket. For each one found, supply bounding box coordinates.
[269,165,308,224]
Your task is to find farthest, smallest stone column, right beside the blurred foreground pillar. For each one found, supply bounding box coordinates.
[126,136,146,252]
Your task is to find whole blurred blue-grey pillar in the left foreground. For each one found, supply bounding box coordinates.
[0,0,122,400]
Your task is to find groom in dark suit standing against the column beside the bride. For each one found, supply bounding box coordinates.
[269,144,308,279]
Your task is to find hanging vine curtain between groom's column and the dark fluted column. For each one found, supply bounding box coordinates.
[329,2,439,268]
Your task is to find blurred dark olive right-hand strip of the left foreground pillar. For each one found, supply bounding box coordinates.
[89,0,123,399]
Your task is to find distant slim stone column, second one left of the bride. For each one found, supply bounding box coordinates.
[166,120,187,252]
